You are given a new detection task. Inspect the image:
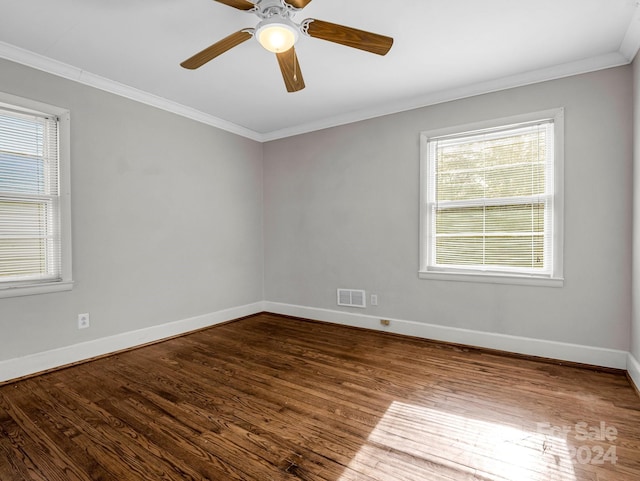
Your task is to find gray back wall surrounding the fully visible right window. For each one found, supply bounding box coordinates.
[264,66,633,350]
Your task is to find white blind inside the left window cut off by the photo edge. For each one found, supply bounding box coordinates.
[0,108,62,285]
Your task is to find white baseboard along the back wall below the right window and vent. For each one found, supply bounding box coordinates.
[264,301,640,370]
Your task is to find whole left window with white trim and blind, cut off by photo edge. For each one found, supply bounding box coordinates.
[0,95,71,297]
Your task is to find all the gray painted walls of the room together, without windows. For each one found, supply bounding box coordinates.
[0,61,640,360]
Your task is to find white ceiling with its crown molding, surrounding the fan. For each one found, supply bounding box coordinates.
[0,0,640,141]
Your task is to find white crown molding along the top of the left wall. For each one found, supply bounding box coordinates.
[0,42,263,142]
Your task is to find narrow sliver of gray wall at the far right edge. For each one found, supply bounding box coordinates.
[631,56,640,360]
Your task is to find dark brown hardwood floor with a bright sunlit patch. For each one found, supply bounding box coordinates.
[0,314,640,481]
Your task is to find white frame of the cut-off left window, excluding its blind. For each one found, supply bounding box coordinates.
[0,92,73,298]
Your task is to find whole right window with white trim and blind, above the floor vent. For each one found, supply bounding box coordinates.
[420,109,563,286]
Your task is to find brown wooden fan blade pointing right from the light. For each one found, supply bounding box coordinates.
[302,18,393,55]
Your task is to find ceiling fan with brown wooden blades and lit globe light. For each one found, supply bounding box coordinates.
[180,0,393,92]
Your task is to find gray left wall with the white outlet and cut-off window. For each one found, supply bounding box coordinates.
[0,61,263,360]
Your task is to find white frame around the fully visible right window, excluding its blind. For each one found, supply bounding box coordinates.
[418,108,564,287]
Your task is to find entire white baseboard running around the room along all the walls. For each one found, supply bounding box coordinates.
[0,301,640,387]
